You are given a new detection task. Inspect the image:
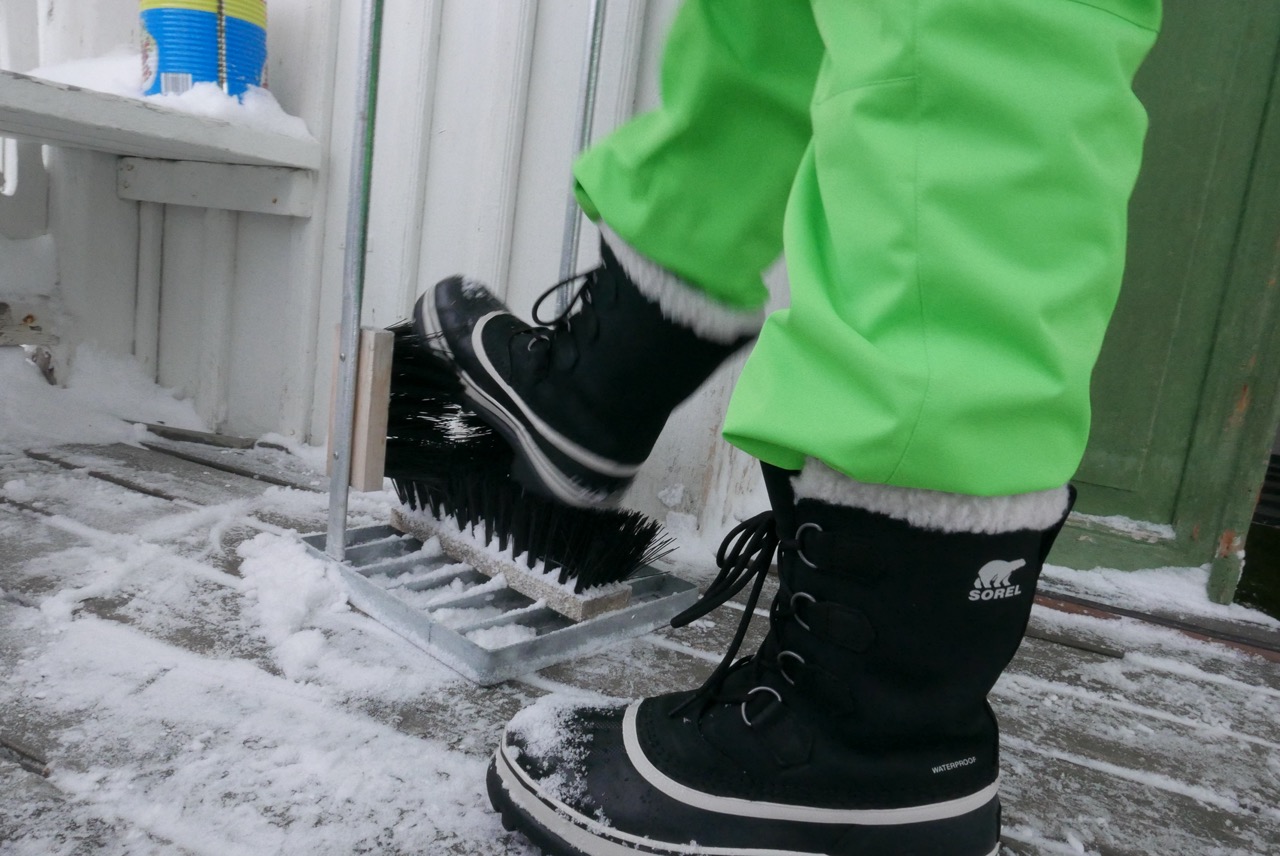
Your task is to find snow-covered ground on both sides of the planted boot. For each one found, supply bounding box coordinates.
[0,349,1280,856]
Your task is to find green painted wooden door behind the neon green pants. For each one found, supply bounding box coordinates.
[1055,0,1280,600]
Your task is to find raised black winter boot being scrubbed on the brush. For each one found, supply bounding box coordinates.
[415,230,763,505]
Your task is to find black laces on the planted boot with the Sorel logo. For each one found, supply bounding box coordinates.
[671,512,813,725]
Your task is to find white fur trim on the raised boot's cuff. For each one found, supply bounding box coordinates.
[599,223,764,344]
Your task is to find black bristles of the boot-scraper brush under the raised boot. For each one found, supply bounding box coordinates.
[385,322,672,592]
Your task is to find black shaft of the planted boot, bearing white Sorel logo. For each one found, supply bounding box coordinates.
[768,460,1059,746]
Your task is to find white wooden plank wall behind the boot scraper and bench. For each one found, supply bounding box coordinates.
[0,0,762,536]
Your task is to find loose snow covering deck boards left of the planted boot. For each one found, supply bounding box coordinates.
[0,463,540,856]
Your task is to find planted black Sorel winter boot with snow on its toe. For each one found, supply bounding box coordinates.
[489,467,1069,856]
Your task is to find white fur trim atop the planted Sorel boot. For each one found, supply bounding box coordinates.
[794,458,1068,535]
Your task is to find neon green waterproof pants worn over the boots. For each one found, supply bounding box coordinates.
[573,0,1160,495]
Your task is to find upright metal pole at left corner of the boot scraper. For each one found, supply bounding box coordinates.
[325,0,383,562]
